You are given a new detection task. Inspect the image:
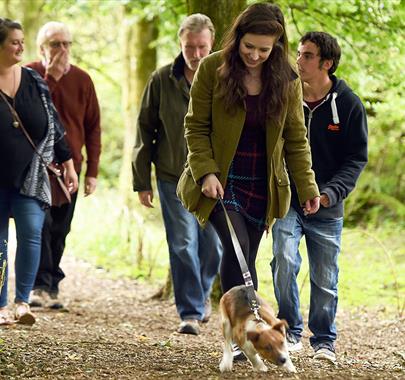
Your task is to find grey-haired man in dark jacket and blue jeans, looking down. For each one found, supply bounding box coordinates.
[132,13,222,335]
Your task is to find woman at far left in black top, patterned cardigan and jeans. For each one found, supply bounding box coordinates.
[0,18,78,325]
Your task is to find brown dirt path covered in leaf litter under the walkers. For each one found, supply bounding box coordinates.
[0,257,405,379]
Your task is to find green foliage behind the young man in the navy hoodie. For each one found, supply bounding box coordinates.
[278,0,405,225]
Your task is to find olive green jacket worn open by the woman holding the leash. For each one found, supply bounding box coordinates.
[177,52,319,226]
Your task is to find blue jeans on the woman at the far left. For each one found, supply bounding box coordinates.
[0,189,45,307]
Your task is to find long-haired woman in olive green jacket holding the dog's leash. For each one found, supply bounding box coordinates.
[177,4,319,291]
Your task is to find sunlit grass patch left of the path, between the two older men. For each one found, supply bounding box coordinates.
[67,191,169,280]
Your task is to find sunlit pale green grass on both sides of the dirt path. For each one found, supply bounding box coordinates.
[67,191,405,316]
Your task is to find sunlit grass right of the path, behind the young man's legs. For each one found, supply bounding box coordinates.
[257,227,405,315]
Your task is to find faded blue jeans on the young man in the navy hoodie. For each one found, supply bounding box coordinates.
[271,207,343,347]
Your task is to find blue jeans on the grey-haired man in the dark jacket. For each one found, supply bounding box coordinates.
[157,179,222,320]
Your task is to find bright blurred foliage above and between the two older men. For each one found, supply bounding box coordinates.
[35,0,185,187]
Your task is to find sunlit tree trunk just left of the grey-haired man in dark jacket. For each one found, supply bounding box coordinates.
[117,7,158,265]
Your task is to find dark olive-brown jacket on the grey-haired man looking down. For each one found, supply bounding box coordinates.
[132,54,190,191]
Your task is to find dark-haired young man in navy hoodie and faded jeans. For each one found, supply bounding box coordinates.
[271,32,367,362]
